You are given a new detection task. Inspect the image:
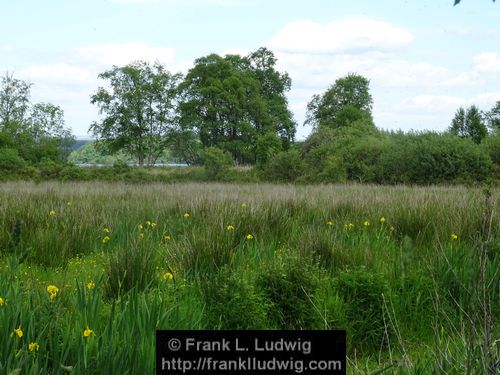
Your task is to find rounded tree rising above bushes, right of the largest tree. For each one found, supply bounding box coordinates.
[305,73,373,129]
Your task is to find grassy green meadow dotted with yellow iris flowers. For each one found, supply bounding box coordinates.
[0,182,500,374]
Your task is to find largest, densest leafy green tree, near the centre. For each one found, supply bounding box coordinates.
[180,48,295,163]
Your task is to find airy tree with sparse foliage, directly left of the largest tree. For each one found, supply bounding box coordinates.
[90,61,182,165]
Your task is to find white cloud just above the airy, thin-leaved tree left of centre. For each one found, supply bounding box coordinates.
[76,42,175,67]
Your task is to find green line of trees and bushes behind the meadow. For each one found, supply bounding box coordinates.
[0,48,500,184]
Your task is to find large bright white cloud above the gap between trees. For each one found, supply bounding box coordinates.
[270,18,413,54]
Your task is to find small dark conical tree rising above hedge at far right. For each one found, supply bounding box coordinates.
[448,105,488,144]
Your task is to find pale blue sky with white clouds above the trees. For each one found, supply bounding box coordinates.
[0,0,500,139]
